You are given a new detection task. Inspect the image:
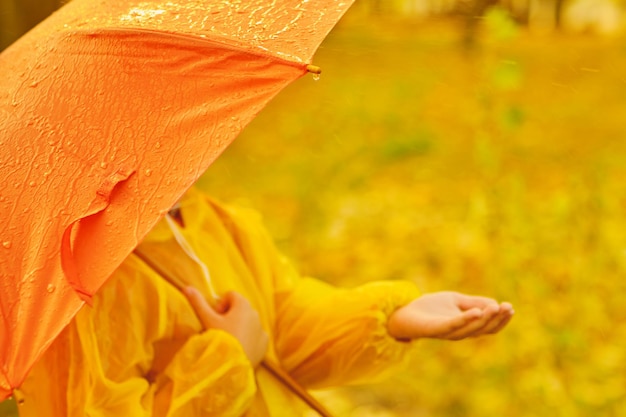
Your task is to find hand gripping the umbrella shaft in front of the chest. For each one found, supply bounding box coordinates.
[184,287,269,367]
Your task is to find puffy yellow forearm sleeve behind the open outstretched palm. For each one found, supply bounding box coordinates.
[276,278,418,388]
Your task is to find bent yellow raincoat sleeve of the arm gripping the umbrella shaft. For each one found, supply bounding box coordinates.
[52,257,256,417]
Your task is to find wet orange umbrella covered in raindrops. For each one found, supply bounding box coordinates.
[0,0,352,400]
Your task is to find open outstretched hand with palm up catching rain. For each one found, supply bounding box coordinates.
[387,291,514,340]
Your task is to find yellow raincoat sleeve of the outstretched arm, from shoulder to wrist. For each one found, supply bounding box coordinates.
[202,195,419,388]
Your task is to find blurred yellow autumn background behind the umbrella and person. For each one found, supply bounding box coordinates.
[0,0,626,417]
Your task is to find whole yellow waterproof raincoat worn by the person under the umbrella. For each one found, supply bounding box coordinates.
[20,190,418,417]
